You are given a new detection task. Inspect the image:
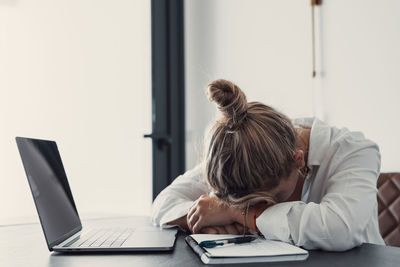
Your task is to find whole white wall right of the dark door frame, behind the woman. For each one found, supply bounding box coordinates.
[185,0,400,171]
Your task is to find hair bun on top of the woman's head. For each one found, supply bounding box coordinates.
[207,79,247,127]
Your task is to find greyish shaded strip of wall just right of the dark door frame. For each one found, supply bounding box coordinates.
[185,0,220,169]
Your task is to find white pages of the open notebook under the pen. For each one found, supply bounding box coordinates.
[192,234,308,257]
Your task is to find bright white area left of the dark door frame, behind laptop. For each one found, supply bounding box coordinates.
[0,0,151,222]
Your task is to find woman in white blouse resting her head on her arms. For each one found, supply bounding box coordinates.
[152,80,384,251]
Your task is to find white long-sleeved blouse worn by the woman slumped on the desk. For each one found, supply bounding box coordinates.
[152,118,385,251]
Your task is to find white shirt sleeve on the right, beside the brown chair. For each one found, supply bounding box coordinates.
[256,137,380,251]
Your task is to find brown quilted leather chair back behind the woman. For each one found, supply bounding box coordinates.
[377,173,400,247]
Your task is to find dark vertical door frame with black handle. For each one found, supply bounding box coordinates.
[145,0,185,200]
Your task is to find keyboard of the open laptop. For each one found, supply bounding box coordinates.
[63,228,134,247]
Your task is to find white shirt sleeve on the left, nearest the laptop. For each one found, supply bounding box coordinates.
[151,164,210,228]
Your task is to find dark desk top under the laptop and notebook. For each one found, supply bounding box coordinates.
[0,217,400,267]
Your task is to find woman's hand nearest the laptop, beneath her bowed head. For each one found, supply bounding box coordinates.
[187,195,240,234]
